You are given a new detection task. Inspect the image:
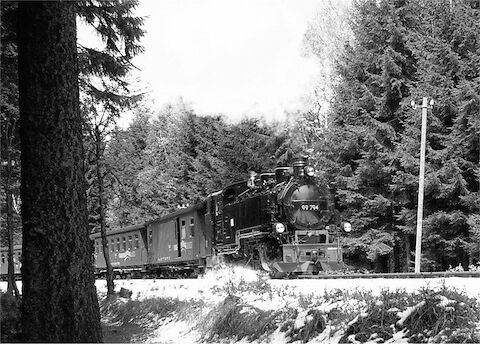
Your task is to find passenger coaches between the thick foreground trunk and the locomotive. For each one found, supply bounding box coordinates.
[90,202,212,277]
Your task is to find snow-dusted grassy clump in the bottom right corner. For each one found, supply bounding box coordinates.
[340,288,480,343]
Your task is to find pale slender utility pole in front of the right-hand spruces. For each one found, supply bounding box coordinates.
[412,97,433,273]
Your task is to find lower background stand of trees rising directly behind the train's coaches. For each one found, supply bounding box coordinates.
[106,99,285,225]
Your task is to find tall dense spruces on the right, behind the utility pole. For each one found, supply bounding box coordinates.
[317,0,480,270]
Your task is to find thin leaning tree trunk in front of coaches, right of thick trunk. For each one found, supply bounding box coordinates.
[95,127,115,295]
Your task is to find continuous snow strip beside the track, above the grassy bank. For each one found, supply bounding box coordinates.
[90,267,480,310]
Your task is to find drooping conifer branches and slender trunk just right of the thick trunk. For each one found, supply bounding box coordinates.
[77,1,143,295]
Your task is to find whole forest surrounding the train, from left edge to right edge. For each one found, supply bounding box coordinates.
[1,0,480,272]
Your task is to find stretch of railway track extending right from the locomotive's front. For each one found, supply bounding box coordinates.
[291,271,480,279]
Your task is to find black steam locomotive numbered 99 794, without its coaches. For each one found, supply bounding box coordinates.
[206,158,348,275]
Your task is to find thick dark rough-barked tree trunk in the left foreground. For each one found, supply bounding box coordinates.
[18,1,102,342]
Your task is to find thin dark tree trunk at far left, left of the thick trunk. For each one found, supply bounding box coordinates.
[5,154,19,298]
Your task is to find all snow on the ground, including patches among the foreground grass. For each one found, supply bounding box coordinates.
[0,267,480,343]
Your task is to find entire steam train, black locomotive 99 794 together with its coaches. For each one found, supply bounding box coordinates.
[2,158,351,277]
